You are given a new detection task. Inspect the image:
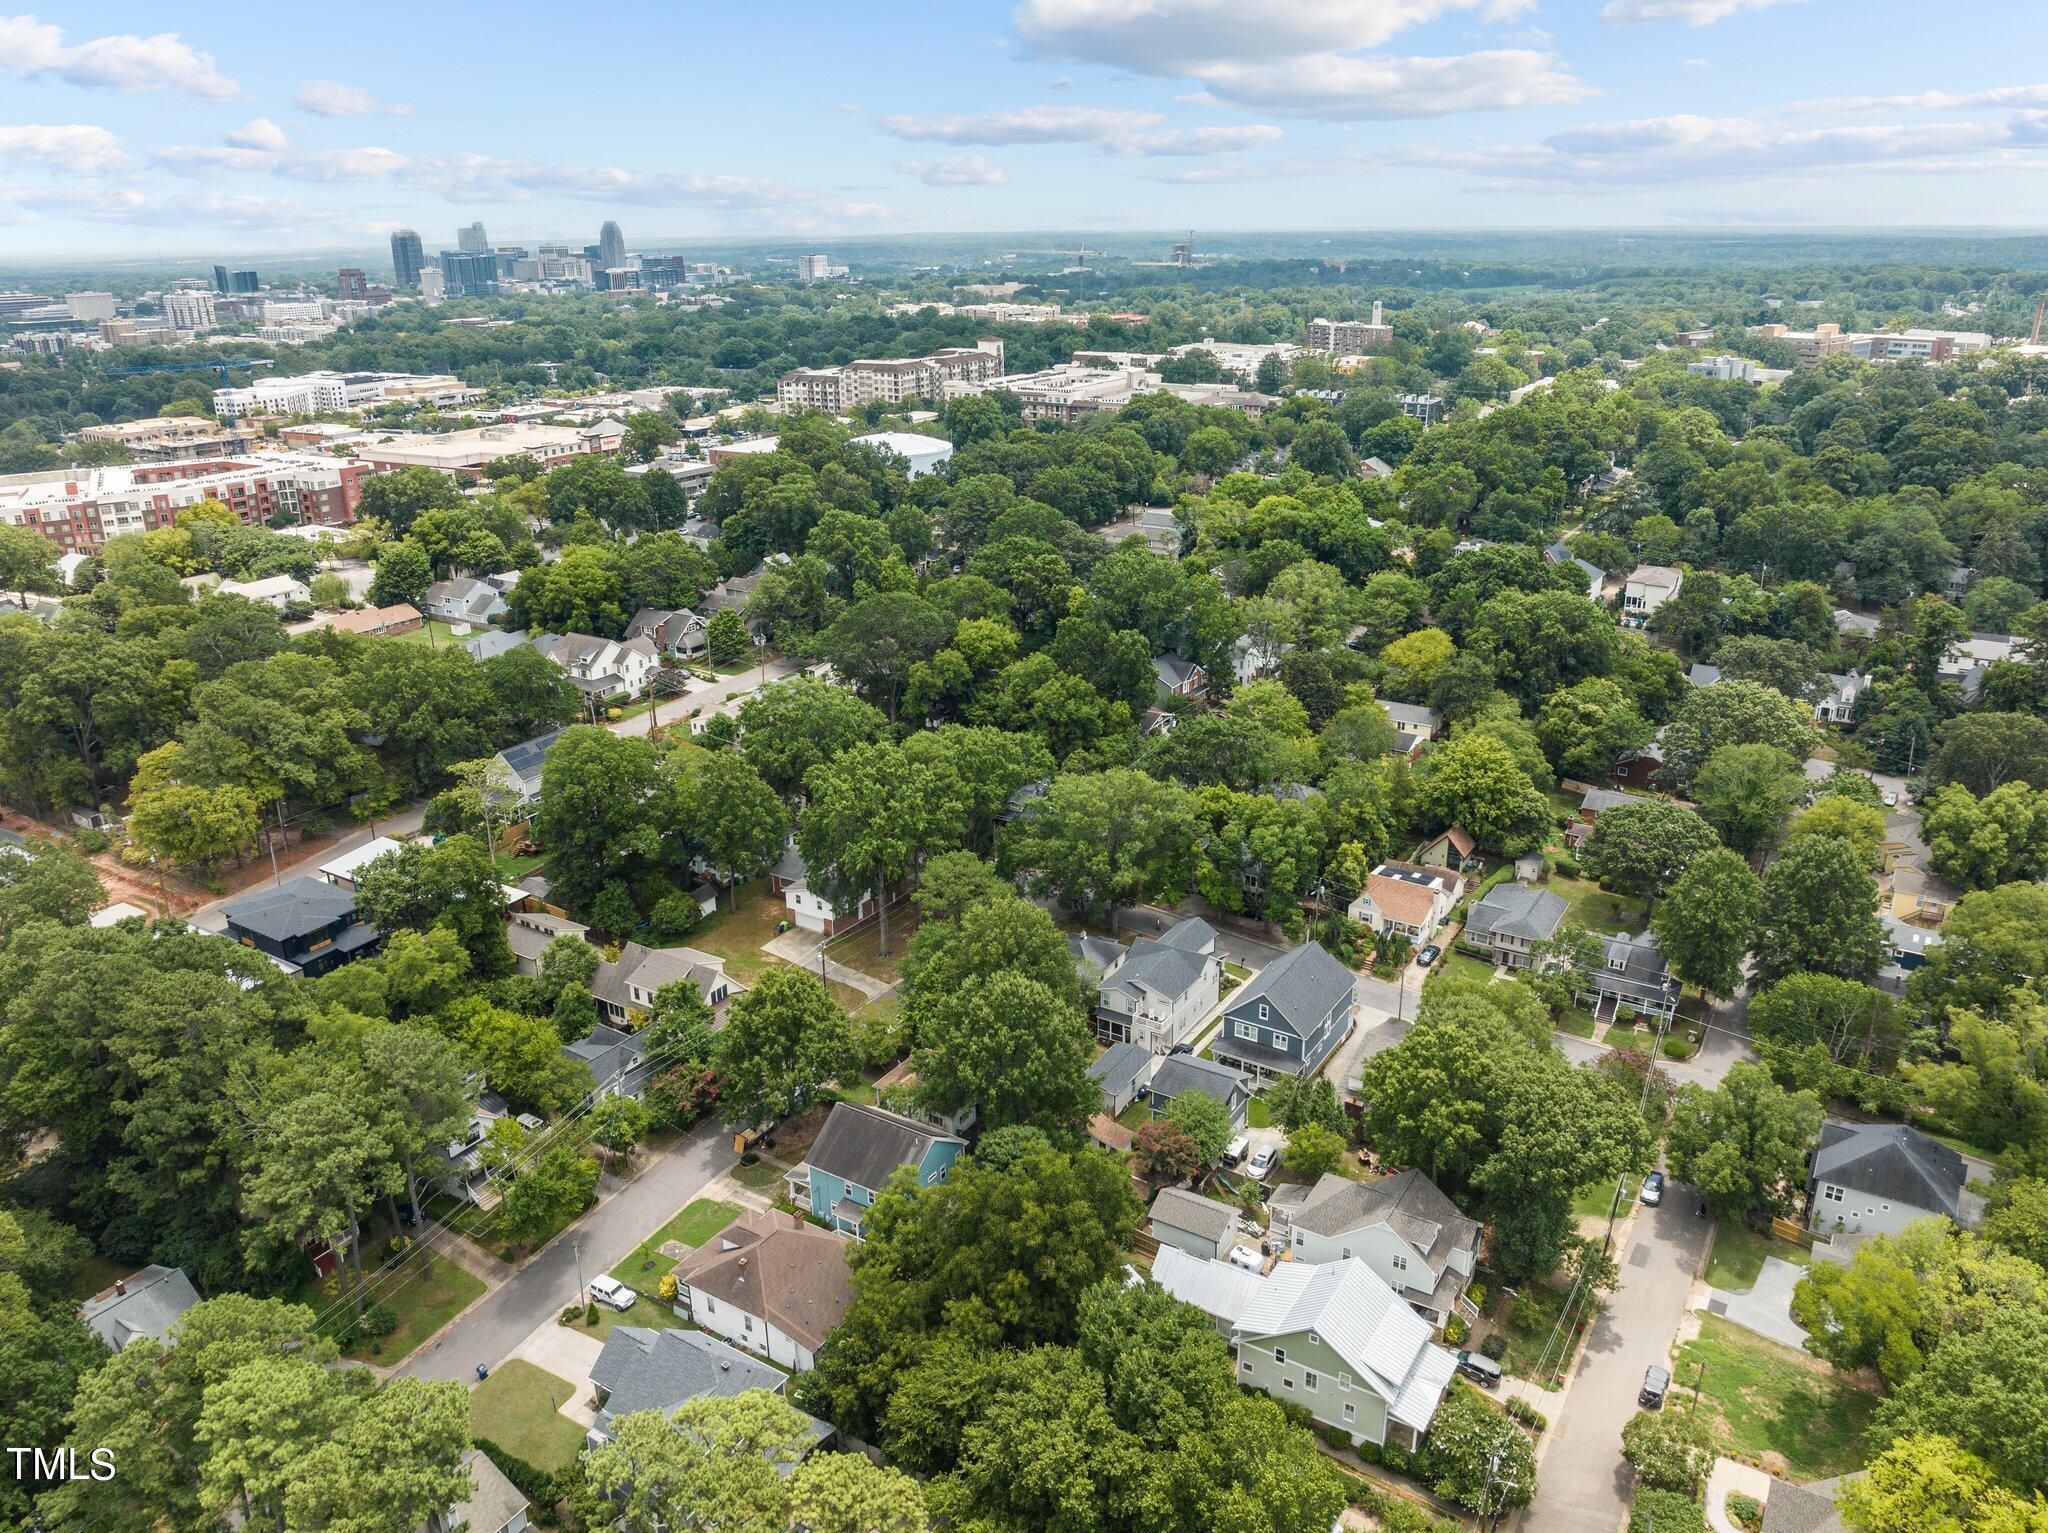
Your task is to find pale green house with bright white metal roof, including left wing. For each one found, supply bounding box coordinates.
[1153,1246,1458,1449]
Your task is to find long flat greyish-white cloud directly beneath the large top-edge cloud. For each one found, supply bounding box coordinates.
[1204,49,1597,121]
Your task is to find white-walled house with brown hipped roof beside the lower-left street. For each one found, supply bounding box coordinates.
[676,1212,854,1371]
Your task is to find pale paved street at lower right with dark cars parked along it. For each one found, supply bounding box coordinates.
[1520,1183,1708,1533]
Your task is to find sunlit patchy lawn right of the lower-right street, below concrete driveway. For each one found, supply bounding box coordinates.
[1671,1314,1878,1480]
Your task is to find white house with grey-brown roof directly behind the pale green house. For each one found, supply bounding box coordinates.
[1272,1169,1485,1326]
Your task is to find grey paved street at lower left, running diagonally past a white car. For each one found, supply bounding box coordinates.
[399,1122,739,1384]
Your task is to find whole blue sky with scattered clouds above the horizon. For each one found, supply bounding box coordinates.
[0,0,2048,264]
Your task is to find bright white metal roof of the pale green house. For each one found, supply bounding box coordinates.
[1237,1259,1458,1431]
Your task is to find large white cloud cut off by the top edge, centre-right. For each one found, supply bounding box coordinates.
[1010,0,1534,76]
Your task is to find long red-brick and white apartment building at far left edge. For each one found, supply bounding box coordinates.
[0,452,371,553]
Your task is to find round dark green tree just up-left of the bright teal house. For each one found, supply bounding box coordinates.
[717,964,856,1128]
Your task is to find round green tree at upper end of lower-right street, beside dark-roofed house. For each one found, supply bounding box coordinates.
[1669,1064,1823,1222]
